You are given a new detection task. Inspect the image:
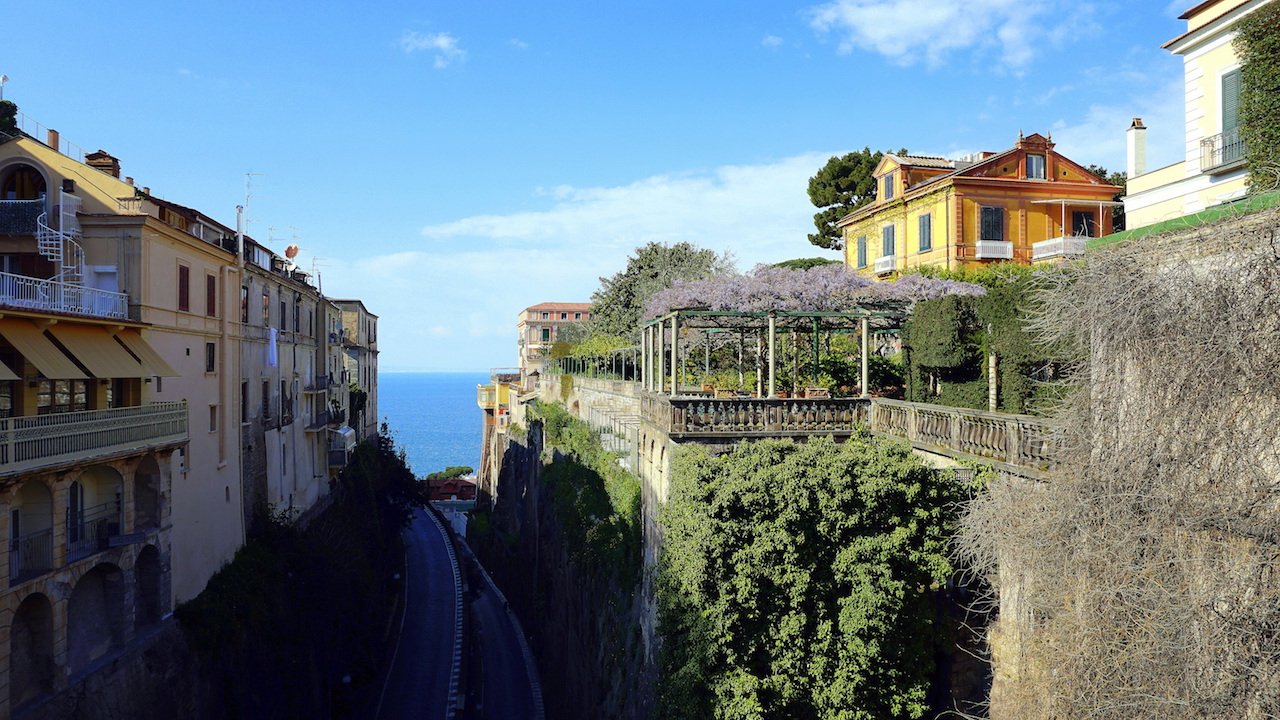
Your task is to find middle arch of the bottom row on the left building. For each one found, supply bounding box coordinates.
[67,562,132,673]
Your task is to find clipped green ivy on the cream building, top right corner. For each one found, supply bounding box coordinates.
[1235,3,1280,192]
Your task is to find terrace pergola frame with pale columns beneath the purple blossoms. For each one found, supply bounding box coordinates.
[640,299,911,397]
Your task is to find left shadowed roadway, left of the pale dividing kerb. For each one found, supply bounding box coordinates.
[376,511,457,720]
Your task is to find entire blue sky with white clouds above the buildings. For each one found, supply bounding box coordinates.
[0,0,1194,372]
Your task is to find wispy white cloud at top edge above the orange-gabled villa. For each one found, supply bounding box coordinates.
[809,0,1089,70]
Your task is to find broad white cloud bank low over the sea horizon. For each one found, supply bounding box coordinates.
[324,152,835,370]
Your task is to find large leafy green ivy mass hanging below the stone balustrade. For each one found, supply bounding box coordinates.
[658,436,960,720]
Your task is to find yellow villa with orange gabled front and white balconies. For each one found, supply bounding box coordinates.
[836,135,1120,275]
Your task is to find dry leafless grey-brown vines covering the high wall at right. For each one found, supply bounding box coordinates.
[960,203,1280,720]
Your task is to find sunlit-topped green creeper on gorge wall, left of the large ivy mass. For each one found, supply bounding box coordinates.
[534,402,641,588]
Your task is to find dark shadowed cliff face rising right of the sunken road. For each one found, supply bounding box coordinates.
[468,423,657,719]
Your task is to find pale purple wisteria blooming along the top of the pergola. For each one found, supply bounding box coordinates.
[644,260,987,319]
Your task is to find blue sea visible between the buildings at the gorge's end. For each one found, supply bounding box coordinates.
[378,373,489,478]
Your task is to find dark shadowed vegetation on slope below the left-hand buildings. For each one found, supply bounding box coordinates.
[174,428,425,719]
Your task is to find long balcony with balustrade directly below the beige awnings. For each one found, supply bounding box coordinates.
[0,402,187,475]
